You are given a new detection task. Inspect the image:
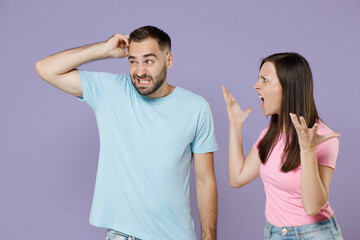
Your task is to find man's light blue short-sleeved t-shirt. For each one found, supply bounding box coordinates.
[80,71,218,240]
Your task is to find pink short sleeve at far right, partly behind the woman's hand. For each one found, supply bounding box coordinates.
[316,128,339,169]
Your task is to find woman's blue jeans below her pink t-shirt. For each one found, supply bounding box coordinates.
[264,216,343,240]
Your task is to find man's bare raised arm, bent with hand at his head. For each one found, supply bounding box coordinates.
[35,34,129,97]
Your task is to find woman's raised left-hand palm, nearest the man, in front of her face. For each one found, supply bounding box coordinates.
[221,86,252,127]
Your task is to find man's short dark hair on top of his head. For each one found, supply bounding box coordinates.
[129,26,171,50]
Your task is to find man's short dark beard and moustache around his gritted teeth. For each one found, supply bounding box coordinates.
[131,63,167,96]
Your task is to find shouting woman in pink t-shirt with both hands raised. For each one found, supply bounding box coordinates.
[222,53,343,240]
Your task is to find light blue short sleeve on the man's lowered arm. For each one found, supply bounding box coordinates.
[191,103,218,153]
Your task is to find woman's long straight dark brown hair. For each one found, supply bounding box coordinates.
[258,53,320,172]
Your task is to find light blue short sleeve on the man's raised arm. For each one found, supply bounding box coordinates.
[77,71,116,110]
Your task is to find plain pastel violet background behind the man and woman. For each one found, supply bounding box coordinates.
[0,0,360,240]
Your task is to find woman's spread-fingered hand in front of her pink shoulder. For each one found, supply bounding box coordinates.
[290,113,341,151]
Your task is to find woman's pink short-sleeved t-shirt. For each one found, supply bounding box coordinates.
[253,121,339,227]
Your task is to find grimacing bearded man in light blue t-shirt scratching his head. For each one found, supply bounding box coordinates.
[36,26,217,240]
